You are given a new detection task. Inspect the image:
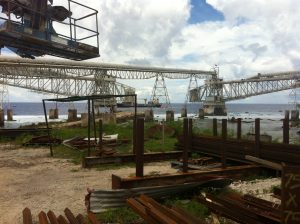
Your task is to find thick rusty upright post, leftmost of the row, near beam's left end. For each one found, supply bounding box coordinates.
[135,118,144,177]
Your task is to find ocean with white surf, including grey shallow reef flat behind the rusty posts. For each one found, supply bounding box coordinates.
[4,103,300,142]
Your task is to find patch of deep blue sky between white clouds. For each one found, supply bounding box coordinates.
[188,0,224,24]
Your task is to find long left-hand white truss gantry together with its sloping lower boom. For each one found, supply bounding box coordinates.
[0,57,216,105]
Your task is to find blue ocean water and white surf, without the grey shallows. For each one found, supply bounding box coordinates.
[0,102,293,124]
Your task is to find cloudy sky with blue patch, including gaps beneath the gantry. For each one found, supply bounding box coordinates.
[2,0,300,103]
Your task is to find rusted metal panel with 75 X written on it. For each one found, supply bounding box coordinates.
[281,166,300,224]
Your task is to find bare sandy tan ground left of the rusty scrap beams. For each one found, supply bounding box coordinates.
[0,145,176,224]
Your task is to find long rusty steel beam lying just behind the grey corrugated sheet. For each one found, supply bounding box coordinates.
[112,165,261,189]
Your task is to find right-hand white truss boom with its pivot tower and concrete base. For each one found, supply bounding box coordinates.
[189,71,300,115]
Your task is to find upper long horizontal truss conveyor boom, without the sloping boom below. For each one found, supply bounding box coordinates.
[0,57,216,79]
